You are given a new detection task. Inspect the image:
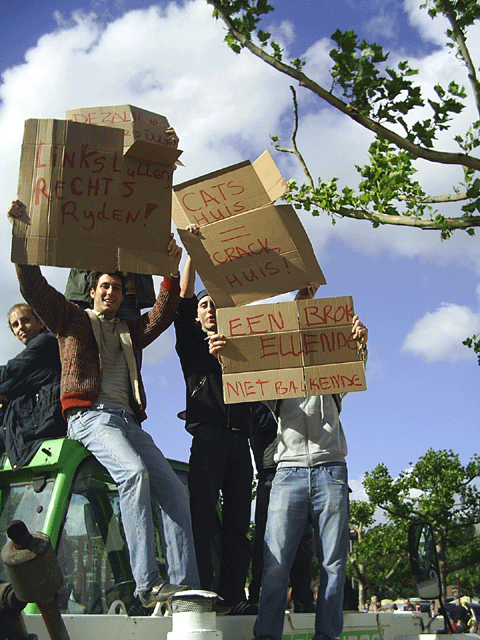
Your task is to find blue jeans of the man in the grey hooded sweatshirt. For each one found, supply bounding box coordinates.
[253,462,349,640]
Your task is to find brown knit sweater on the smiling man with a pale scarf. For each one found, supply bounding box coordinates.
[16,265,180,422]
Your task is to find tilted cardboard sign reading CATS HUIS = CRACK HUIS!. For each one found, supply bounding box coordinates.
[172,151,326,307]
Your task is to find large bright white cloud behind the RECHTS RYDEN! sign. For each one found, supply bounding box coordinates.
[0,0,290,362]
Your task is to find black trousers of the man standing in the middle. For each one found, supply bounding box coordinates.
[188,424,253,604]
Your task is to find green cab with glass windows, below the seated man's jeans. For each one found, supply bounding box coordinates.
[0,438,188,615]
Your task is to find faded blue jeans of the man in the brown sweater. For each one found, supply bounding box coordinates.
[68,403,200,593]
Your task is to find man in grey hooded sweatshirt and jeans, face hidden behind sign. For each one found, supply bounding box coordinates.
[210,283,368,640]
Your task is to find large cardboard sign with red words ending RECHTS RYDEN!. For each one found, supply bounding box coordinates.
[12,107,180,275]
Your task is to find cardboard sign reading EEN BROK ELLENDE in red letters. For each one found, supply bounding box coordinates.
[217,296,366,404]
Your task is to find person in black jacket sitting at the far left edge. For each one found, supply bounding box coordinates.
[0,303,67,469]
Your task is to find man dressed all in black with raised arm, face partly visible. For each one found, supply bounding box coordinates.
[174,228,254,615]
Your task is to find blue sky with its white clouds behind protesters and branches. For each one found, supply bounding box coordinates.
[0,0,480,497]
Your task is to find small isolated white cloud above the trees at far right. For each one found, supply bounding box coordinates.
[403,303,480,362]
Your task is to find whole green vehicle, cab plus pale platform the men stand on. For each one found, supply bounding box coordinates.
[0,438,468,640]
